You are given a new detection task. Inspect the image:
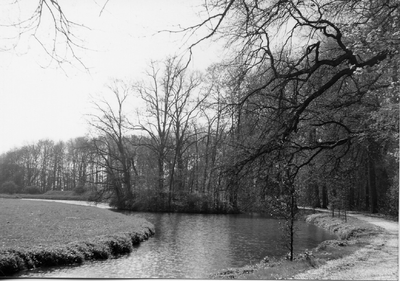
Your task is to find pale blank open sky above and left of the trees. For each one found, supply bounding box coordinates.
[0,0,219,153]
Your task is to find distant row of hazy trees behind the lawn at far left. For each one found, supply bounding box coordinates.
[0,137,95,194]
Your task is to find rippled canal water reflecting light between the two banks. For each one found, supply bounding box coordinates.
[20,212,335,278]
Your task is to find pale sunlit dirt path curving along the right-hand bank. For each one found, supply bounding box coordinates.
[294,213,399,280]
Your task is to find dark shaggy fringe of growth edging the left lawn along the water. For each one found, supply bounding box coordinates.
[0,200,155,276]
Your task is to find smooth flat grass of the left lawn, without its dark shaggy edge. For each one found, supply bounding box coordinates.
[0,198,152,249]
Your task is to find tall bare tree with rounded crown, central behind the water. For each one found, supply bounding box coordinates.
[136,57,205,205]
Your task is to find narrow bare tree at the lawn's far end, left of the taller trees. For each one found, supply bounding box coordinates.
[89,81,135,208]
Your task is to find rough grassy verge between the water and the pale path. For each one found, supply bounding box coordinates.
[210,213,382,280]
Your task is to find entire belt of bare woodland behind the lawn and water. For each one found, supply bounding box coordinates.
[0,0,400,215]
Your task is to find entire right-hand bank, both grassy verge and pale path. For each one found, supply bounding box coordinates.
[211,210,399,280]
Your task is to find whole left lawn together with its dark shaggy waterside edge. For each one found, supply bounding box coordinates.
[0,198,154,276]
